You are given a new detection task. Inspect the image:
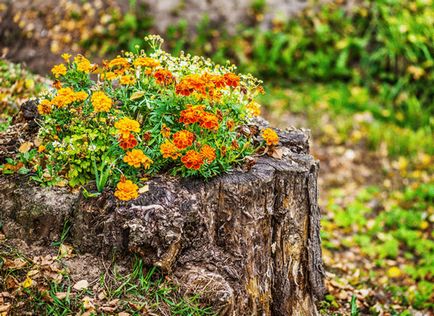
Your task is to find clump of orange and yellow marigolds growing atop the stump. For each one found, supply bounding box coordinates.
[30,36,278,201]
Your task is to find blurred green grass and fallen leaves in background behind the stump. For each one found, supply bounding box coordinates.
[0,0,434,315]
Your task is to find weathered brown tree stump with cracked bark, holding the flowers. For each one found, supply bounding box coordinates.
[0,102,324,315]
